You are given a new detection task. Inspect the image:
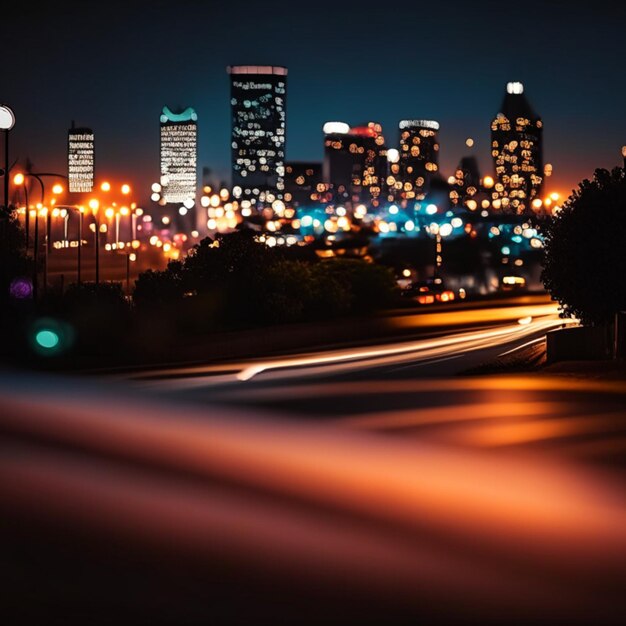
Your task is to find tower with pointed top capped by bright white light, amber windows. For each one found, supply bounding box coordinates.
[491,82,543,213]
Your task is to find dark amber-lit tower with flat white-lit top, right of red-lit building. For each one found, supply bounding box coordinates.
[396,120,439,199]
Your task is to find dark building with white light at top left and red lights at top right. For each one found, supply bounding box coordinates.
[323,122,387,205]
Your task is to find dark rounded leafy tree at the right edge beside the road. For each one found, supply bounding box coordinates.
[541,168,626,325]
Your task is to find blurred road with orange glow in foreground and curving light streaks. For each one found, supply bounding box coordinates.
[0,298,626,625]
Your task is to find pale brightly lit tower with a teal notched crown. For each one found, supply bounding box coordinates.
[161,106,198,204]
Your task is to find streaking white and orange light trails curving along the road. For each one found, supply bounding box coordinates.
[124,303,578,390]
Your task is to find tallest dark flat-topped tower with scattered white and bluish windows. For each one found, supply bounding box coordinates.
[227,65,287,209]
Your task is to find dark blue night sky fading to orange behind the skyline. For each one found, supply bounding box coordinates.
[0,0,626,199]
